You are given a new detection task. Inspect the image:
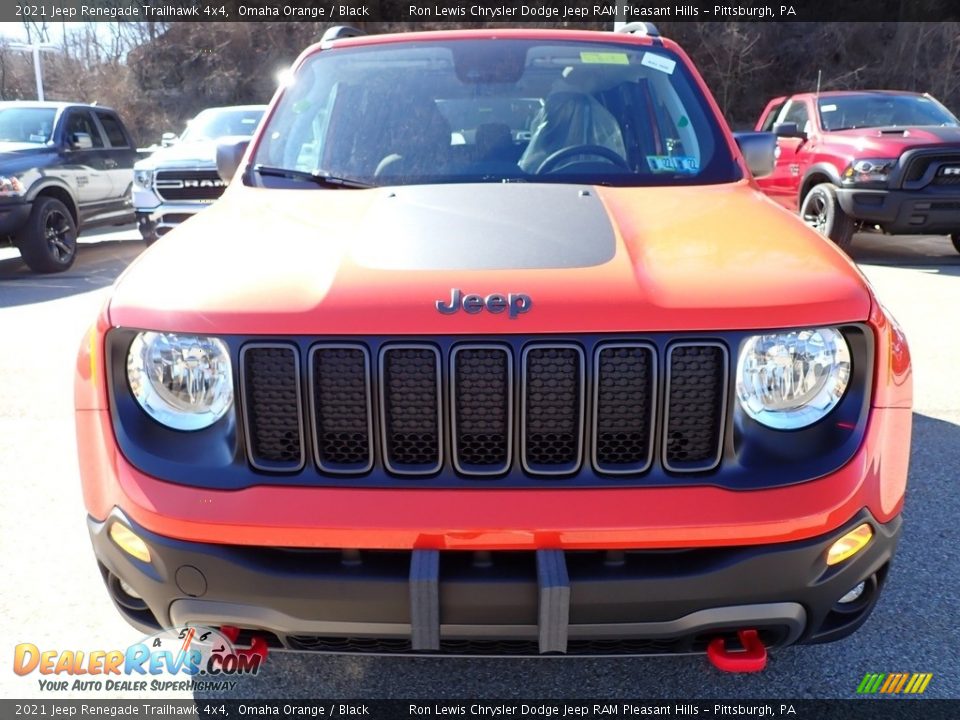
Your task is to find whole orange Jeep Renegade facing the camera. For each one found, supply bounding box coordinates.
[76,25,912,670]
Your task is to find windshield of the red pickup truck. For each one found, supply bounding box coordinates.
[819,93,958,130]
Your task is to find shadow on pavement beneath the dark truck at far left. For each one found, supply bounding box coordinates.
[0,240,144,307]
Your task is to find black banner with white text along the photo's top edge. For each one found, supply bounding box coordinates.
[0,0,960,26]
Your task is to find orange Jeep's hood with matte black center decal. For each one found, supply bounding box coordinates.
[109,181,871,335]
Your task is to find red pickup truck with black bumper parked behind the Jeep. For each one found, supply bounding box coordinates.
[756,91,960,252]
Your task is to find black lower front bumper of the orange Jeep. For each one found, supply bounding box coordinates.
[88,511,901,655]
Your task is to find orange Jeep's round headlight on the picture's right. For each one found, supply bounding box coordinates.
[737,328,850,430]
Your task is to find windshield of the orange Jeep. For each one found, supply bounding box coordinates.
[248,39,740,187]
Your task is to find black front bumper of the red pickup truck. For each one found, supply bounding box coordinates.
[837,187,960,235]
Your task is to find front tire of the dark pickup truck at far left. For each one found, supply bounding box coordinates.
[15,196,77,273]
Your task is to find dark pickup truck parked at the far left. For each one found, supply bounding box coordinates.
[0,101,137,273]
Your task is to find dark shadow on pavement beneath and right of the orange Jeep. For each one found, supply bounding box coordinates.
[194,413,960,701]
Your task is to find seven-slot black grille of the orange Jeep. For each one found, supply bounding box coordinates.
[240,339,729,482]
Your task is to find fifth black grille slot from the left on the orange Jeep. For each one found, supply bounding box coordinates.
[523,345,584,475]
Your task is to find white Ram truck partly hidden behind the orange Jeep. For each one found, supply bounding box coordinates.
[133,105,266,244]
